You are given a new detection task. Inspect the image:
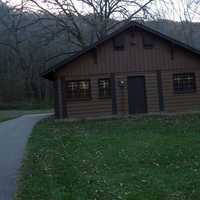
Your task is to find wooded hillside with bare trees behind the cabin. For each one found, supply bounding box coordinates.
[0,0,200,109]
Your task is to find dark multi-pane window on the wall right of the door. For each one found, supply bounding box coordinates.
[173,73,196,93]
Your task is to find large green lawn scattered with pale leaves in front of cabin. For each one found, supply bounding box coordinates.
[17,114,200,200]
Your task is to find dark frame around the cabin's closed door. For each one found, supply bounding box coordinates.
[127,75,148,115]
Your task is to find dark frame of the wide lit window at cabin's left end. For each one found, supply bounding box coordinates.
[66,79,92,101]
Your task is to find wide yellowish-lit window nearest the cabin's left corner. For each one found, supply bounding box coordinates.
[67,80,91,99]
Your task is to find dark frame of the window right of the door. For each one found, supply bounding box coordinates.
[172,72,197,94]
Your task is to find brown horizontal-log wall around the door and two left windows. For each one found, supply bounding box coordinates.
[60,73,159,118]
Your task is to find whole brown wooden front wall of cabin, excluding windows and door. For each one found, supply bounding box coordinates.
[56,27,200,118]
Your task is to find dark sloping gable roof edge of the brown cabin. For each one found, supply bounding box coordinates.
[41,22,200,80]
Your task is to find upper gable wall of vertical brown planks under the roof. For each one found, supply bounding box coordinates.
[57,29,200,77]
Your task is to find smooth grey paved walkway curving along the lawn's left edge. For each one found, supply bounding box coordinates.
[0,114,48,200]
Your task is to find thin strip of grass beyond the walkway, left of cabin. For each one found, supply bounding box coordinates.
[0,110,50,122]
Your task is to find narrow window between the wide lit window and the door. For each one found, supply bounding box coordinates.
[99,78,111,98]
